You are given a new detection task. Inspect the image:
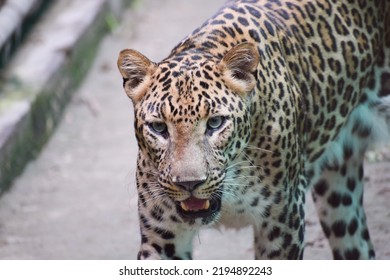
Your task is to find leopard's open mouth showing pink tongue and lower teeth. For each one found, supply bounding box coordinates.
[176,196,221,219]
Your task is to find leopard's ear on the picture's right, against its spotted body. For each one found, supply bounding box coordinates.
[218,43,260,94]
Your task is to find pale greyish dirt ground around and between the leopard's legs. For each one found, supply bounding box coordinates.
[0,0,390,259]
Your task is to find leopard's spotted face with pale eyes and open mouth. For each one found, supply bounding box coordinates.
[118,44,257,223]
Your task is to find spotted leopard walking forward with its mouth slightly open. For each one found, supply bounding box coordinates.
[117,0,390,259]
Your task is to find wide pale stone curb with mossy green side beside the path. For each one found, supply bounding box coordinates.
[0,0,132,194]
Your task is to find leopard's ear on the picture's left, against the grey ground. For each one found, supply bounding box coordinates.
[118,49,157,104]
